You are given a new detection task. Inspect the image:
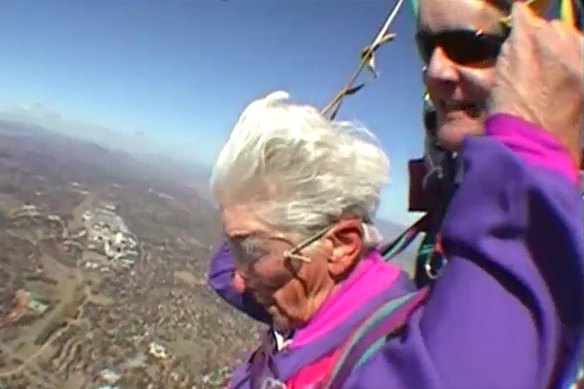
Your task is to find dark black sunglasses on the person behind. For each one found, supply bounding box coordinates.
[416,28,510,67]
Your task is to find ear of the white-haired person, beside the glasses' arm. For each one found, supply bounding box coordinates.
[326,219,363,277]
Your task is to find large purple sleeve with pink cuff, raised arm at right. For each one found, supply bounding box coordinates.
[344,115,584,389]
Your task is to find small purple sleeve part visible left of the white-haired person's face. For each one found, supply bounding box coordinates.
[207,242,271,324]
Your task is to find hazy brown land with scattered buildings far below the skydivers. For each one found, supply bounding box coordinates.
[0,120,410,389]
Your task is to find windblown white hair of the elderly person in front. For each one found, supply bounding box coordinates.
[210,91,389,245]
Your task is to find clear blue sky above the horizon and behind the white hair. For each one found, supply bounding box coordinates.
[0,0,422,223]
